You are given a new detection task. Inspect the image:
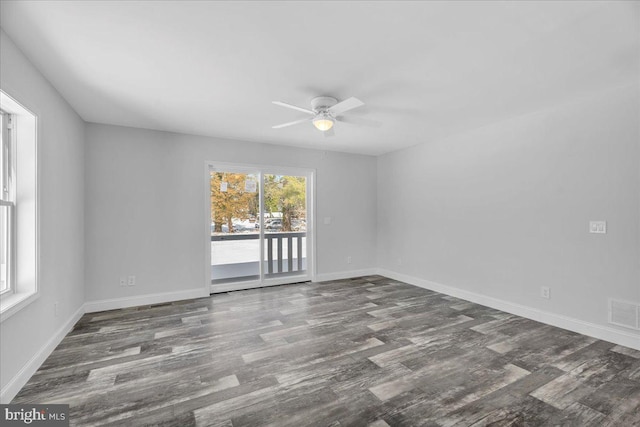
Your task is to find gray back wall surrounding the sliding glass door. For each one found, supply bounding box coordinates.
[85,124,377,301]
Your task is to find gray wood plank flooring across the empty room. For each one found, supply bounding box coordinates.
[13,276,640,427]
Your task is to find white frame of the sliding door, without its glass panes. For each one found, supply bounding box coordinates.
[204,161,316,293]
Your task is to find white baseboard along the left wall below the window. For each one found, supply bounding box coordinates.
[0,305,84,404]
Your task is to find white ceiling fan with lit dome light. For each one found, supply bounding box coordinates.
[273,96,364,136]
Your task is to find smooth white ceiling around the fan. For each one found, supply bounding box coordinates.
[0,1,640,155]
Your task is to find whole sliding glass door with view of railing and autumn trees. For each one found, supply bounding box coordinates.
[207,164,313,292]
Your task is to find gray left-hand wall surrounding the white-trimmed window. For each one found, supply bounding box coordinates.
[0,31,84,396]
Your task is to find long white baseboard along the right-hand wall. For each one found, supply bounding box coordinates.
[377,269,640,350]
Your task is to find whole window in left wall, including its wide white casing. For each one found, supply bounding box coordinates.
[0,90,39,321]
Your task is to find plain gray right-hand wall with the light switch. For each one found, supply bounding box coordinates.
[378,86,640,333]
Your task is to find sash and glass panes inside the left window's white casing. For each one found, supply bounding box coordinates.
[0,110,16,294]
